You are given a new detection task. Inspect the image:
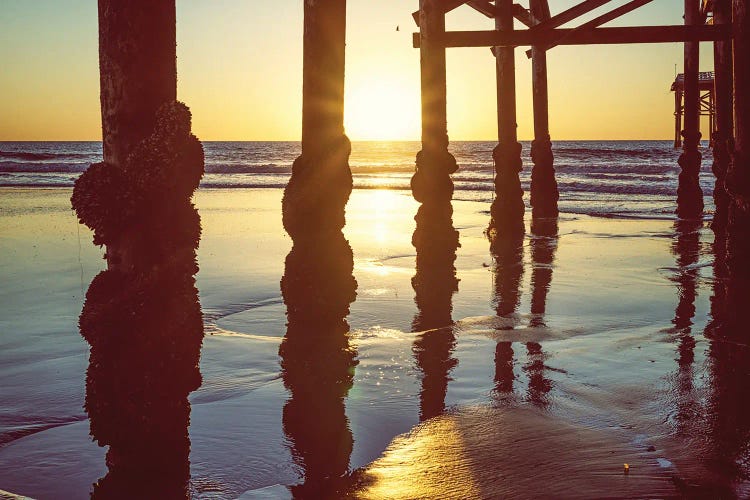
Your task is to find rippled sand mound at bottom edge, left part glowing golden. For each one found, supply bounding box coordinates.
[358,407,677,499]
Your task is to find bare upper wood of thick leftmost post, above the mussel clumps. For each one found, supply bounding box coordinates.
[99,0,177,167]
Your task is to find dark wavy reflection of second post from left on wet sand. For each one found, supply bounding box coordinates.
[279,231,357,498]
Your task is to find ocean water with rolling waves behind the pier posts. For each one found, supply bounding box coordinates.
[0,141,714,218]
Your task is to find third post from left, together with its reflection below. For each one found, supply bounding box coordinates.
[411,0,459,421]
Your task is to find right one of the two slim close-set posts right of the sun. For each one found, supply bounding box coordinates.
[530,0,560,217]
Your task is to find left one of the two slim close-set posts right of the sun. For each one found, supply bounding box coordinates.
[488,0,525,238]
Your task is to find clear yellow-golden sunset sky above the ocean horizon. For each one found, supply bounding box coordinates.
[0,0,712,141]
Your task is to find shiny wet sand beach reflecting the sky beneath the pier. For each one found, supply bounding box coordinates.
[0,188,750,498]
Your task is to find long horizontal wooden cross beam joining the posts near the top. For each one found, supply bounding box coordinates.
[414,25,732,48]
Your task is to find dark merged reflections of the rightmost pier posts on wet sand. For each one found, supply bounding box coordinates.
[673,221,750,498]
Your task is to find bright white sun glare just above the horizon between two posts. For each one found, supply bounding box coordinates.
[344,80,420,140]
